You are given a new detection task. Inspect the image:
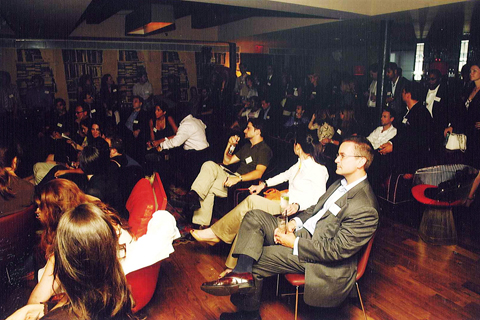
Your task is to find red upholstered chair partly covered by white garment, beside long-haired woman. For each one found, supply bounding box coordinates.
[127,172,167,312]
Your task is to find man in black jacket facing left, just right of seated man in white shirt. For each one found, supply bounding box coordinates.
[378,82,433,174]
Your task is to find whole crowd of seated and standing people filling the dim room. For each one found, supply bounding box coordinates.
[0,58,480,319]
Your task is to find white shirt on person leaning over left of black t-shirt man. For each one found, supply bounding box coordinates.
[160,114,209,151]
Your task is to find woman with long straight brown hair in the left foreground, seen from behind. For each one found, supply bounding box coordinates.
[9,204,135,320]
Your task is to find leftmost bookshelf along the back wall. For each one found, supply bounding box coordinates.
[17,49,57,104]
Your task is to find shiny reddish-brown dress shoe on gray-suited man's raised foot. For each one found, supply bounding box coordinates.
[201,272,255,296]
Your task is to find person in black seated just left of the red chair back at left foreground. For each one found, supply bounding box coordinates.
[78,144,127,218]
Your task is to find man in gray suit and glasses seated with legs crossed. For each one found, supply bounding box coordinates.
[202,137,378,320]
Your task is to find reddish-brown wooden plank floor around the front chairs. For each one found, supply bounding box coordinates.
[142,201,480,320]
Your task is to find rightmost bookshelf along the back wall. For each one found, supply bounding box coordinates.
[162,51,190,101]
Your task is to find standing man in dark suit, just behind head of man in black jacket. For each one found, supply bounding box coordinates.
[385,62,408,127]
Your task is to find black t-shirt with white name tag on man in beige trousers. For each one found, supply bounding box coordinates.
[235,141,273,174]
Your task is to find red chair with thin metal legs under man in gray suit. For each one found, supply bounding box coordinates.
[277,233,375,320]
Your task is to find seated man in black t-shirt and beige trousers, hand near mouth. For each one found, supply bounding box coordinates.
[186,119,272,226]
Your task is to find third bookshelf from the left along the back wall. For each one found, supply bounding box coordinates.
[117,50,146,104]
